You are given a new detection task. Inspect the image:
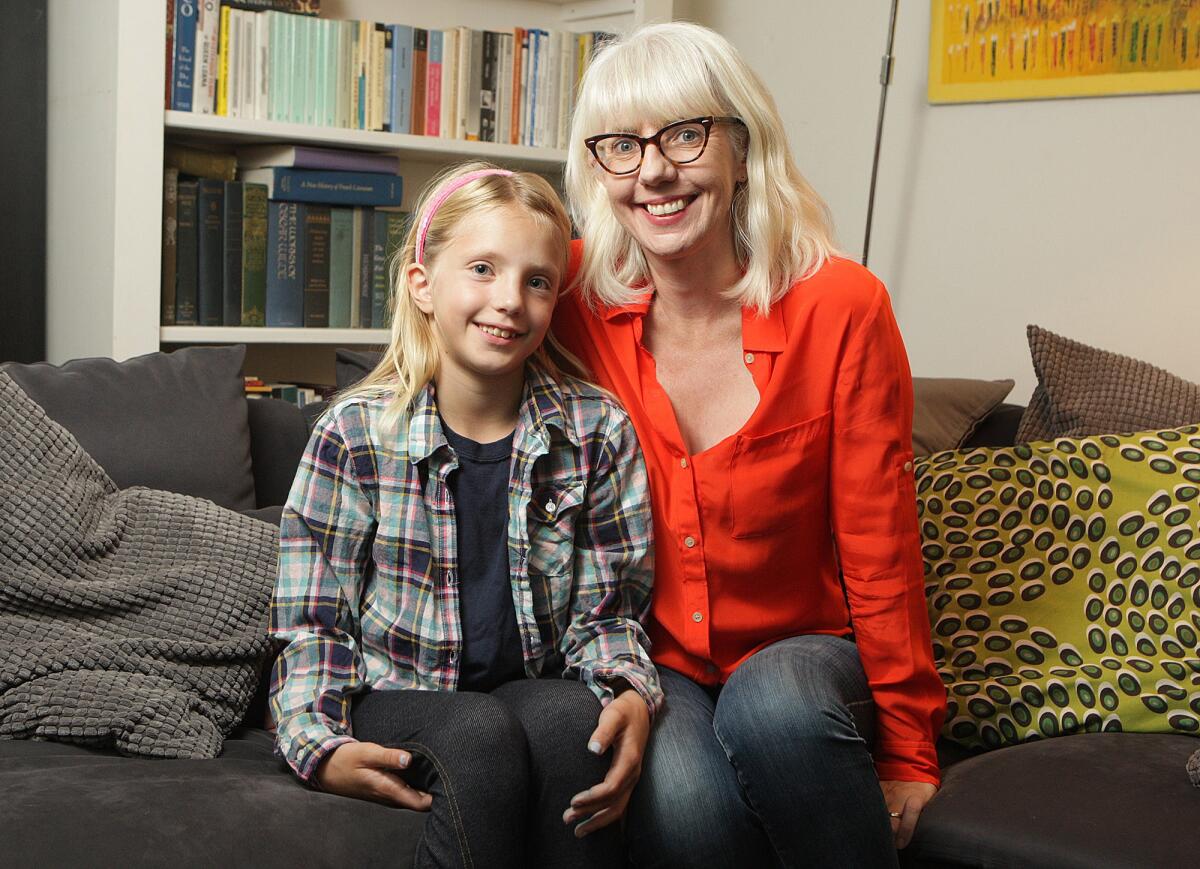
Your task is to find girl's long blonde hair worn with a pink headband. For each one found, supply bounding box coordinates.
[334,161,578,426]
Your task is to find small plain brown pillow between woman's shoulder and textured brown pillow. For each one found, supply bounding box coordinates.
[912,377,1013,456]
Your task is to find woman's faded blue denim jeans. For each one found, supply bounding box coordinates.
[626,635,898,869]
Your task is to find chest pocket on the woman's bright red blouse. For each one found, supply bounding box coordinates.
[730,412,832,538]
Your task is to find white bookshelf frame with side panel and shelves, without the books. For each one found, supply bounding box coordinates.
[46,0,672,379]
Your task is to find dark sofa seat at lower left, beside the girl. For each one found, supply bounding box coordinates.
[0,729,425,869]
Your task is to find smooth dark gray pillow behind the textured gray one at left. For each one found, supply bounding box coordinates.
[4,344,256,510]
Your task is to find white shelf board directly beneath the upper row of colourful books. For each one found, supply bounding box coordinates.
[163,112,566,173]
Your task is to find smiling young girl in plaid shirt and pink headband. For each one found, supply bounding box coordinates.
[271,163,661,867]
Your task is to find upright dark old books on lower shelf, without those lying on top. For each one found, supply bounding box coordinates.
[161,167,408,329]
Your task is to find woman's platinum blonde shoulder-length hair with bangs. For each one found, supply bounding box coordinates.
[564,22,835,313]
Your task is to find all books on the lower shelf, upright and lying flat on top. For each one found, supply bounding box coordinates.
[162,145,407,329]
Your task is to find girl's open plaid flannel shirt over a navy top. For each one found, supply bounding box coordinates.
[270,365,662,781]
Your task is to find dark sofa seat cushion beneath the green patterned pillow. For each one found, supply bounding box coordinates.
[901,733,1200,869]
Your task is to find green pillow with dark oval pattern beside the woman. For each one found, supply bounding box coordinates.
[916,425,1200,748]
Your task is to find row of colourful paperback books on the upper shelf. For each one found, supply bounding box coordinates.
[166,0,612,148]
